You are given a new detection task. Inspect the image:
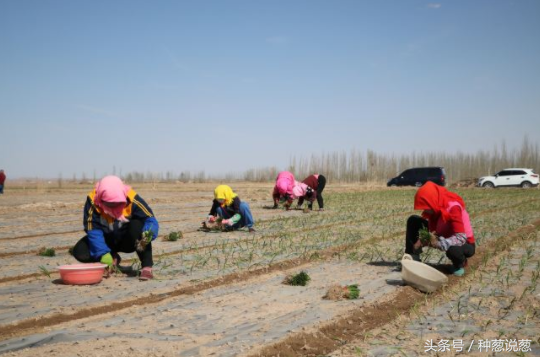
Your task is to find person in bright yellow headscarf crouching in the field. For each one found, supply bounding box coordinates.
[207,185,255,232]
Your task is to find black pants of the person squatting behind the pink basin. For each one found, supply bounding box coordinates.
[73,219,154,268]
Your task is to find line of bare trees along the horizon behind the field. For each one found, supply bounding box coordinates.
[86,137,540,183]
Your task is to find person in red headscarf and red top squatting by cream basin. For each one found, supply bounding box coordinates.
[405,181,475,276]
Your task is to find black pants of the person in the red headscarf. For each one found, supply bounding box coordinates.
[405,215,476,269]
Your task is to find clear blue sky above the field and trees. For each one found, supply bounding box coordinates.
[0,0,540,178]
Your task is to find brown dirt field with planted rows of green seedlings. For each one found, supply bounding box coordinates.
[0,183,540,357]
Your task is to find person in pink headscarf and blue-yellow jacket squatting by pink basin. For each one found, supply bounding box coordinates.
[73,176,159,280]
